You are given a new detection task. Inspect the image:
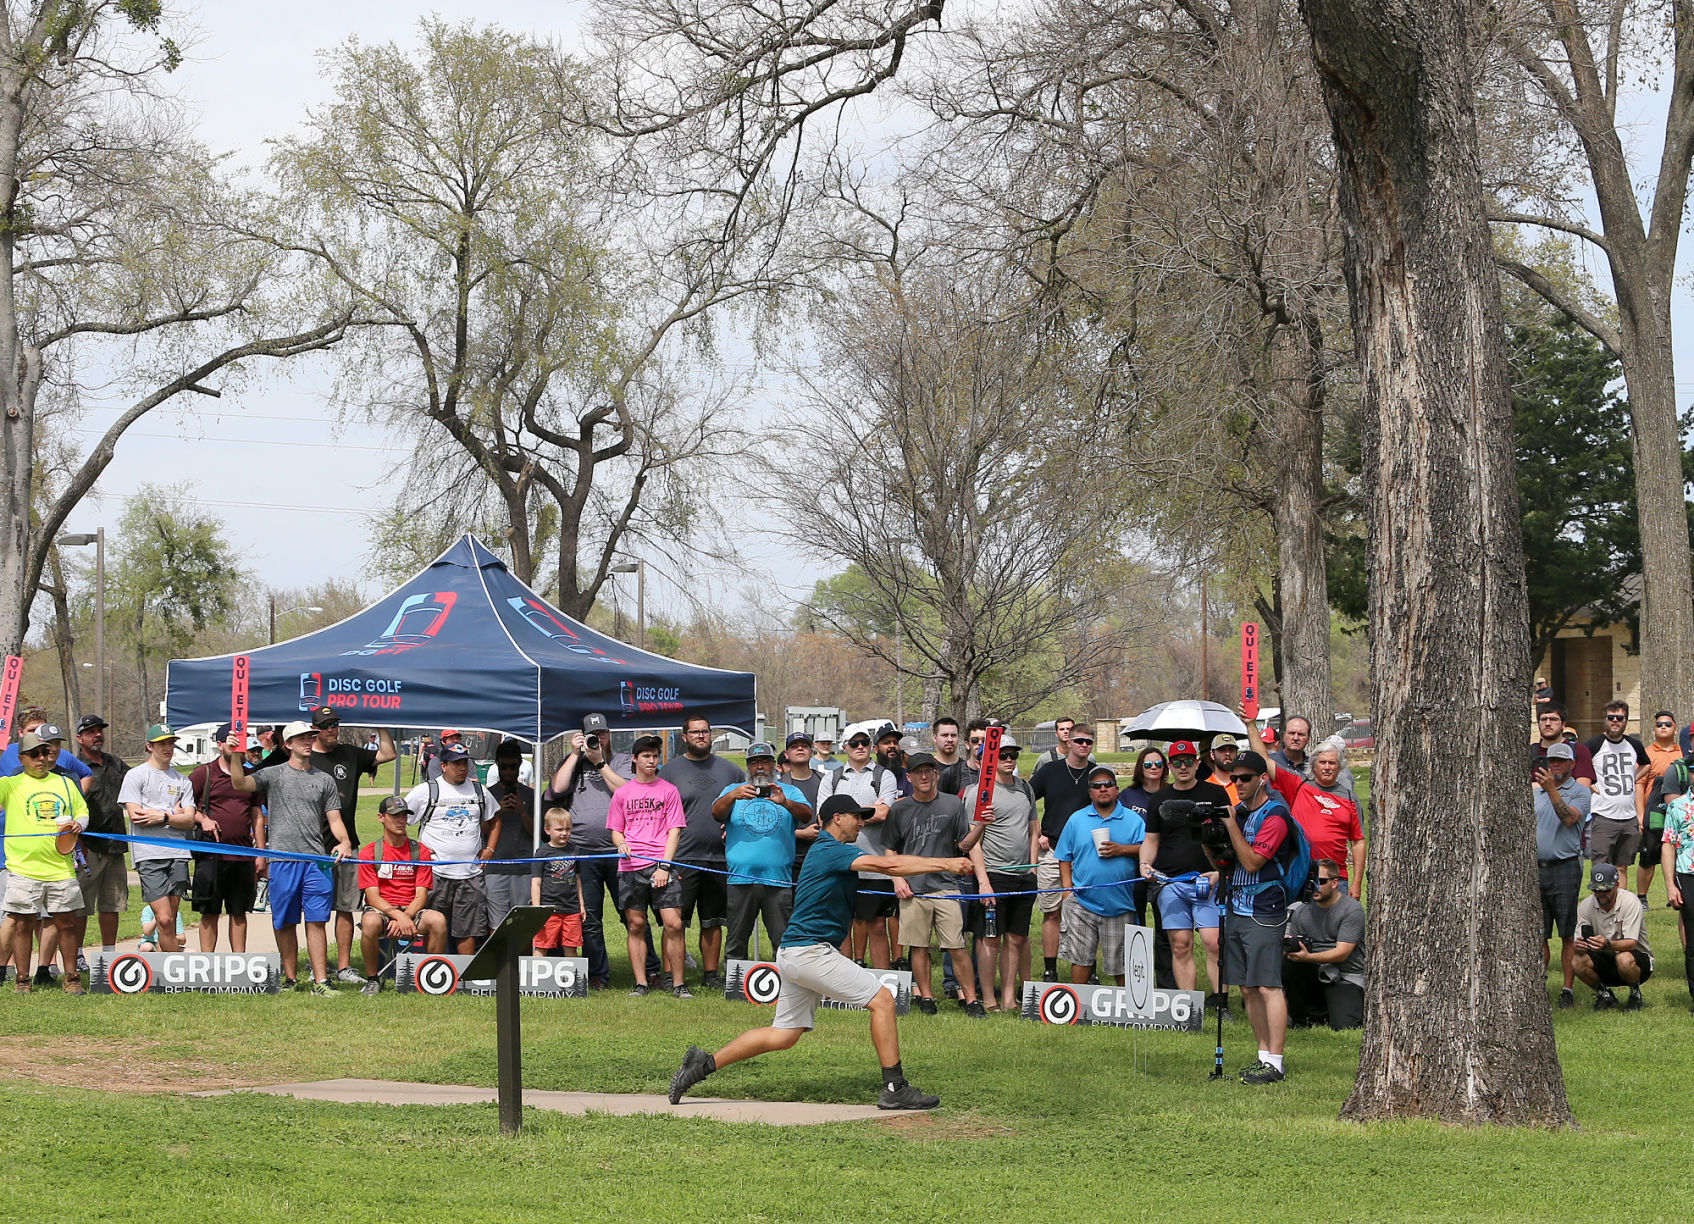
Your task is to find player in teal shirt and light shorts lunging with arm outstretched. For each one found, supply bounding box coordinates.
[671,794,974,1109]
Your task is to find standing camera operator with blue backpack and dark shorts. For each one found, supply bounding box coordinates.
[1201,752,1294,1083]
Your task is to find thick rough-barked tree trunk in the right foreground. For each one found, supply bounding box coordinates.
[1304,0,1570,1124]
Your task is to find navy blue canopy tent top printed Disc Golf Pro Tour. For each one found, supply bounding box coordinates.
[164,535,754,748]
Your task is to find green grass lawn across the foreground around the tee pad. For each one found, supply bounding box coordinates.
[0,873,1694,1224]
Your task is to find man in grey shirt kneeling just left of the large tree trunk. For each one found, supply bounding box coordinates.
[1282,858,1365,1031]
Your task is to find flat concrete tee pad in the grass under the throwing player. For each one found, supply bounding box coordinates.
[191,1080,898,1126]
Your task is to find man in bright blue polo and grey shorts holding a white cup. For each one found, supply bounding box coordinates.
[1054,765,1147,985]
